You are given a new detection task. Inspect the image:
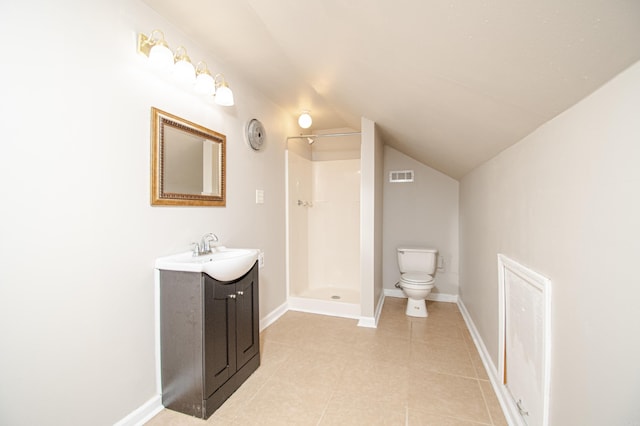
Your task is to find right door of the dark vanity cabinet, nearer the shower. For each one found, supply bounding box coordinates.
[236,265,260,368]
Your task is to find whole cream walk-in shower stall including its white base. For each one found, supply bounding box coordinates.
[287,132,361,318]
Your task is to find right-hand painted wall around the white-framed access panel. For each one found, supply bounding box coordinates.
[460,63,640,426]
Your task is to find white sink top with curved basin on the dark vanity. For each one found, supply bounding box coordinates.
[156,246,259,281]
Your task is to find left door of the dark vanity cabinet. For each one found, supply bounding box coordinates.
[204,276,237,398]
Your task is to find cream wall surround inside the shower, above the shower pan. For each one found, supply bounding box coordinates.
[289,151,360,303]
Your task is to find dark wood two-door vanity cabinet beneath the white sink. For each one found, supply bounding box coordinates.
[160,263,260,419]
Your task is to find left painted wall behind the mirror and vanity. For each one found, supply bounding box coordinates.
[0,0,290,425]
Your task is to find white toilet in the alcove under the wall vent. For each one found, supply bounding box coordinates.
[396,248,438,317]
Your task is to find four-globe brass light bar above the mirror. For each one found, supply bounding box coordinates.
[137,30,234,106]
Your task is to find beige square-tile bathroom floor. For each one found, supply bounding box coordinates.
[147,297,507,426]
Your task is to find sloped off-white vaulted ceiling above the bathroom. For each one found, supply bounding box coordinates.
[145,0,640,179]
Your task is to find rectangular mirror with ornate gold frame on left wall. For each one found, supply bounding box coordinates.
[151,107,227,206]
